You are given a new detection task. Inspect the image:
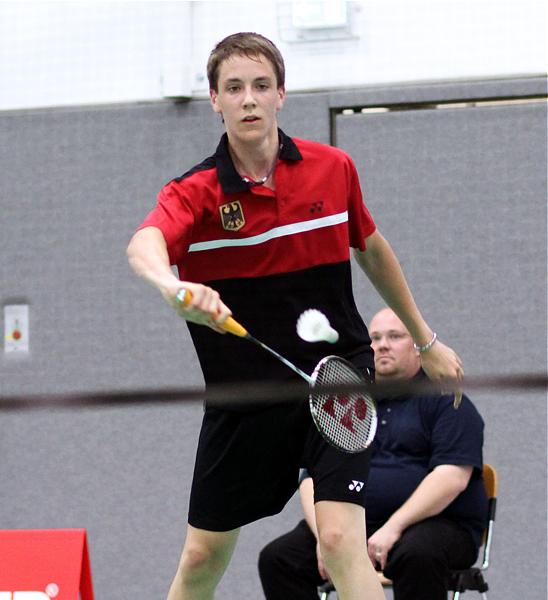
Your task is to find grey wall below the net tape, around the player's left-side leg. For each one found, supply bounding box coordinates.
[0,404,301,600]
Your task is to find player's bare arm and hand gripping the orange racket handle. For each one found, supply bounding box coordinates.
[127,227,231,333]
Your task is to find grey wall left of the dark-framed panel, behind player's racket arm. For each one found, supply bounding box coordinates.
[0,95,329,600]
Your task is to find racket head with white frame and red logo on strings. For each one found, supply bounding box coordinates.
[309,356,377,453]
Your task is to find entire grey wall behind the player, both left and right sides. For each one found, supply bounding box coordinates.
[0,79,546,600]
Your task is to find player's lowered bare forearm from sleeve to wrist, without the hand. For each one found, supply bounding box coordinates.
[355,231,433,345]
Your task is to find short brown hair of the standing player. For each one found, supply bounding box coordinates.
[207,31,285,92]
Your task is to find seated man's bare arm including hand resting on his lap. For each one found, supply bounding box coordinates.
[367,465,473,569]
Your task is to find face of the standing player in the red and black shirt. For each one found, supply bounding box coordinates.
[210,55,285,143]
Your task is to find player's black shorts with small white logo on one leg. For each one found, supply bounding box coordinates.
[188,401,370,531]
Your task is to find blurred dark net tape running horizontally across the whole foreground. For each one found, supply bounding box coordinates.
[0,373,548,411]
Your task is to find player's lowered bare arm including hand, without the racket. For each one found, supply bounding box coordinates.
[354,231,463,379]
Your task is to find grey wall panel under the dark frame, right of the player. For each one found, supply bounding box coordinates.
[337,103,546,600]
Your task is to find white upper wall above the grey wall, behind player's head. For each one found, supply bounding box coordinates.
[0,0,547,110]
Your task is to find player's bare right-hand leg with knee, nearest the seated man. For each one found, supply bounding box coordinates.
[315,501,385,600]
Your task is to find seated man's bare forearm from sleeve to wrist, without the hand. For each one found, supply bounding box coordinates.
[386,465,472,533]
